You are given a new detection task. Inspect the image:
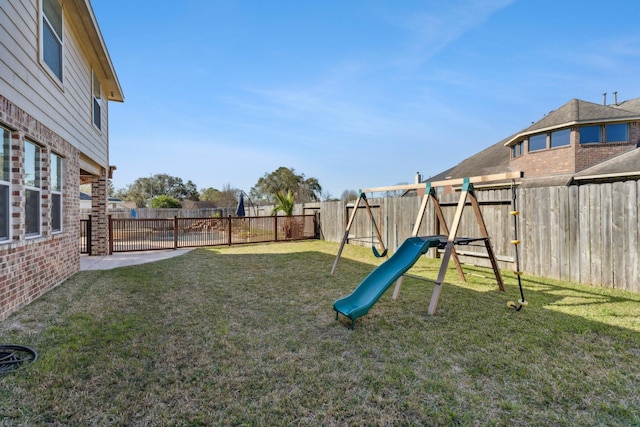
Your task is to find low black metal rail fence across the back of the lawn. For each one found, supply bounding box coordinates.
[109,215,318,253]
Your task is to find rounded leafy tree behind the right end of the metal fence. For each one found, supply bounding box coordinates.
[249,166,322,203]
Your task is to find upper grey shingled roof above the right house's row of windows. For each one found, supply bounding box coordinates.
[505,98,640,146]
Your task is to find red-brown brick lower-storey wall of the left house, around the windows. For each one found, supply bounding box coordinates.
[0,95,80,320]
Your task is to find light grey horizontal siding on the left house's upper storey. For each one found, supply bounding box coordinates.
[0,0,109,169]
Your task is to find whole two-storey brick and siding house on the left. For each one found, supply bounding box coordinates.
[0,0,124,320]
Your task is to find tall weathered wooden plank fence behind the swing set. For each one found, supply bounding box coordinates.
[319,180,640,292]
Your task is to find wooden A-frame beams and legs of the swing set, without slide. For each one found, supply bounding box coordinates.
[331,172,522,315]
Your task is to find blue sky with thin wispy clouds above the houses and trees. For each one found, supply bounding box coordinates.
[92,0,640,197]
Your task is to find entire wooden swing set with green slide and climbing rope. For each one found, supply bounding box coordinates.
[331,172,527,329]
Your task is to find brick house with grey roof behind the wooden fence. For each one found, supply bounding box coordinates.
[429,98,640,186]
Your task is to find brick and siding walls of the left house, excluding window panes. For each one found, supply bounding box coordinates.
[0,0,116,320]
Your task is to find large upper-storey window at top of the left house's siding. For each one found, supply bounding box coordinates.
[41,0,64,82]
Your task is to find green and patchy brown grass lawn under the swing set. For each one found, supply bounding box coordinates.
[0,241,640,426]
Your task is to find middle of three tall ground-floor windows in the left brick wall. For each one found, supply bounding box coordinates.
[24,141,42,237]
